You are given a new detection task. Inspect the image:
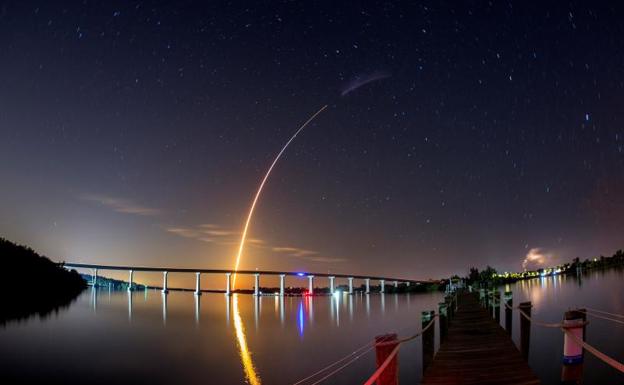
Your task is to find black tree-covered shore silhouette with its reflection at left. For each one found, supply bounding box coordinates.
[0,238,87,325]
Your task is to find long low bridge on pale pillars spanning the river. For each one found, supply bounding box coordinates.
[64,262,436,296]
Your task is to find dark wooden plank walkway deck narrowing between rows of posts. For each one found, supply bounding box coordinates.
[422,293,540,385]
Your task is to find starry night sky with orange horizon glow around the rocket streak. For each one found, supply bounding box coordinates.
[0,1,624,279]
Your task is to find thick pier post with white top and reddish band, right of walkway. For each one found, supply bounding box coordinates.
[561,310,587,385]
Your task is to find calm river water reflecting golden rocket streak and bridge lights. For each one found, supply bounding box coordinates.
[0,270,624,384]
